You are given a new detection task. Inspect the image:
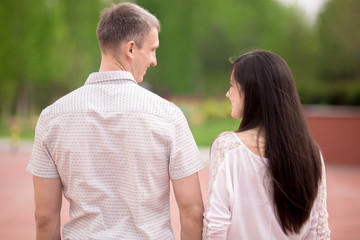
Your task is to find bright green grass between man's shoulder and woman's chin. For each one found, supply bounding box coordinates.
[190,118,240,147]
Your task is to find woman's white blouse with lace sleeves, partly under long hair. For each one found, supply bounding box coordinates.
[203,132,330,240]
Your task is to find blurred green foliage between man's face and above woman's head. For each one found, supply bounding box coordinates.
[141,0,318,95]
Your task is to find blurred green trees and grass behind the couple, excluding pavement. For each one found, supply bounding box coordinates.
[0,0,360,148]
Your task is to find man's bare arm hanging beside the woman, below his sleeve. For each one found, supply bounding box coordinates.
[172,173,204,240]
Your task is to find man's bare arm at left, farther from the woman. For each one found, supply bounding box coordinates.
[33,176,62,240]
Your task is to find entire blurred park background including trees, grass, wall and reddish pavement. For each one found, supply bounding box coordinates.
[0,0,360,239]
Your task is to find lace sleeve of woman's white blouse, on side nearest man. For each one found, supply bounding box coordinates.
[203,132,240,239]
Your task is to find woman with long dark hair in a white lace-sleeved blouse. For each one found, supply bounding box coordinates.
[203,50,330,240]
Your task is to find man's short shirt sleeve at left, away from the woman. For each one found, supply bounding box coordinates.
[26,113,59,178]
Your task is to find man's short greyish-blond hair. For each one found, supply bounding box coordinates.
[96,2,160,51]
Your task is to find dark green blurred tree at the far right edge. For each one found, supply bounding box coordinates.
[317,0,360,104]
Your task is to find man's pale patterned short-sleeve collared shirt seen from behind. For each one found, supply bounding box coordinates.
[27,71,204,239]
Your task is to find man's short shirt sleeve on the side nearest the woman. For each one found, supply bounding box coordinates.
[169,108,204,179]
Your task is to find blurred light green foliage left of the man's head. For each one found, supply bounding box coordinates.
[0,0,104,115]
